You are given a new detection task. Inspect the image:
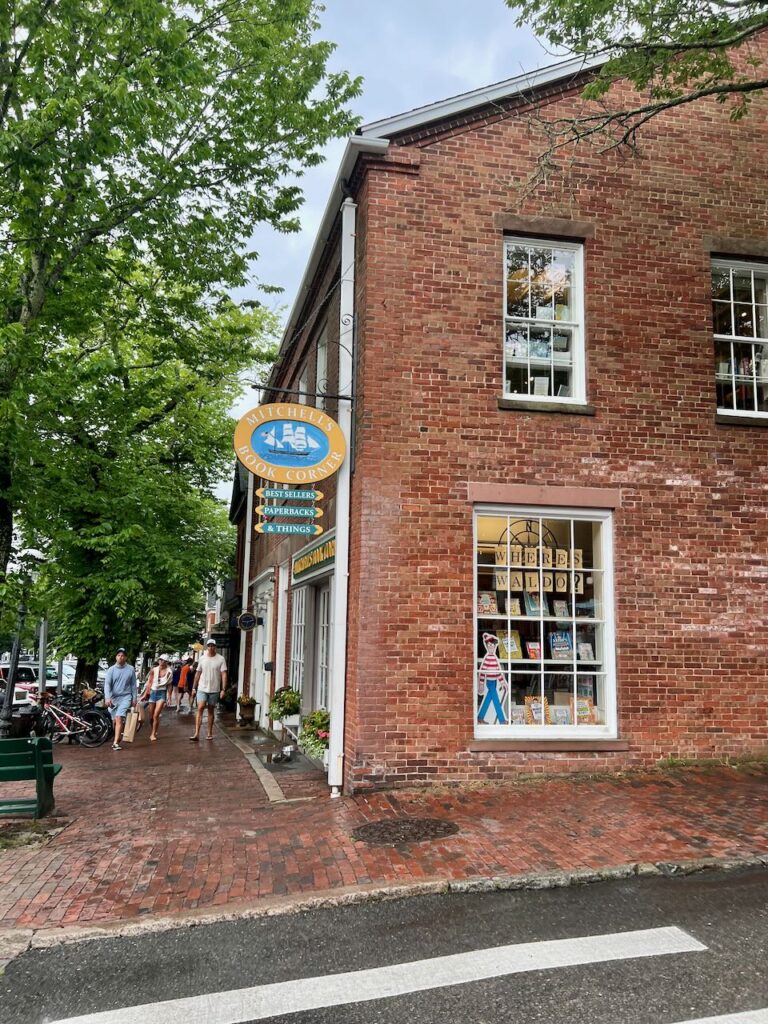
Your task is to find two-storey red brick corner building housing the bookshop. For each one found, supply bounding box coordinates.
[233,51,768,792]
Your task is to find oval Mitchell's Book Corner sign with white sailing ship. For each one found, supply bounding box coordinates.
[234,402,346,483]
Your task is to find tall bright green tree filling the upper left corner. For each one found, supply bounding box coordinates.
[0,0,359,575]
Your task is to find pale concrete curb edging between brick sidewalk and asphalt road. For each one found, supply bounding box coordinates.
[0,854,768,973]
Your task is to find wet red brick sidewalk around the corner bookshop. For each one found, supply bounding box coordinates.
[0,712,768,931]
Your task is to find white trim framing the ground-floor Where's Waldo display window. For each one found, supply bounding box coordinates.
[470,505,618,744]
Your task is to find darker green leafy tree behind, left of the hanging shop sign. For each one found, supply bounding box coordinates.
[19,268,278,676]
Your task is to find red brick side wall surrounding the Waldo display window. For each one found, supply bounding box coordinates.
[345,64,768,788]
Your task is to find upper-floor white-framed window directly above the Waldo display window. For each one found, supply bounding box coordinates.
[503,238,586,403]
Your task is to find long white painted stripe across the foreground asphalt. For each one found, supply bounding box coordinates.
[51,927,708,1024]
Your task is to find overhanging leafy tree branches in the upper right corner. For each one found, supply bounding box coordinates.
[506,0,768,172]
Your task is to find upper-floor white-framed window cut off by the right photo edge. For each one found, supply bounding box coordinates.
[712,259,768,418]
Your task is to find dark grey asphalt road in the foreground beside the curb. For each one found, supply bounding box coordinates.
[0,871,768,1024]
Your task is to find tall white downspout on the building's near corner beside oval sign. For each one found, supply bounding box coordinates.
[328,199,357,797]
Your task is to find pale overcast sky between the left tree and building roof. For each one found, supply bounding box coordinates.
[218,0,552,500]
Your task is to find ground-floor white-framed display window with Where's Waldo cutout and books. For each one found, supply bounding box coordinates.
[474,506,616,740]
